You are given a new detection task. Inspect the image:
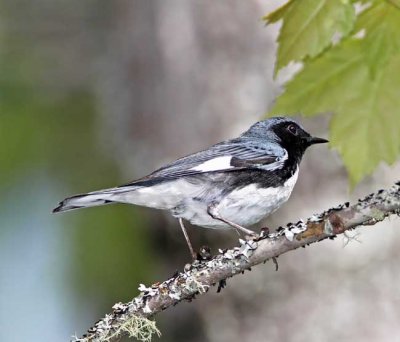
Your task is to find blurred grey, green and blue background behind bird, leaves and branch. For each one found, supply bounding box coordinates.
[0,0,400,342]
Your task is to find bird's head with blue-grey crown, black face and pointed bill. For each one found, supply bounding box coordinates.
[243,117,328,153]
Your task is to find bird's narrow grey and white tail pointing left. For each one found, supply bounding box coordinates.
[53,188,132,213]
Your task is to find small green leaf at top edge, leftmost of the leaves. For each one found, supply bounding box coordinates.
[265,0,355,74]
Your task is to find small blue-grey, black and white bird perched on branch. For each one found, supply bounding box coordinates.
[53,117,328,260]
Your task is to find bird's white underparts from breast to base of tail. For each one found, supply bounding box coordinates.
[114,169,299,229]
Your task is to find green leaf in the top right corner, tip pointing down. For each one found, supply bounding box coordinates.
[355,2,400,77]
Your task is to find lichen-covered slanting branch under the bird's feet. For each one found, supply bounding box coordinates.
[74,182,400,342]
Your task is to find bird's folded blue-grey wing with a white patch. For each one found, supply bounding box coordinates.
[122,138,288,187]
